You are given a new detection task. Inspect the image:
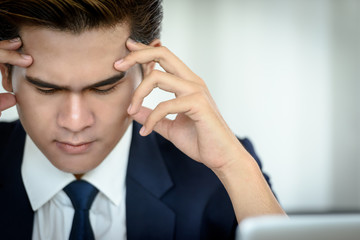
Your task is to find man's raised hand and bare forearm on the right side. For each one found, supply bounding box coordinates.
[115,40,285,222]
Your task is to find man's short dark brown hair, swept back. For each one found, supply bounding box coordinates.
[0,0,163,44]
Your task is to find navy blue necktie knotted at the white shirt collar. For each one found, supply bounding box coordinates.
[64,180,99,240]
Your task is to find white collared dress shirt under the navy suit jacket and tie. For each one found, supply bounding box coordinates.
[21,126,132,240]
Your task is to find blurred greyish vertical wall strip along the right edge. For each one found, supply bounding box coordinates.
[330,0,360,209]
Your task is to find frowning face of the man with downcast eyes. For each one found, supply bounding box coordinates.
[12,24,141,174]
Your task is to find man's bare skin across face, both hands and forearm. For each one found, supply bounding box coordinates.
[0,25,284,221]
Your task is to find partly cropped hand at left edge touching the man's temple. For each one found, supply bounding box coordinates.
[0,38,32,116]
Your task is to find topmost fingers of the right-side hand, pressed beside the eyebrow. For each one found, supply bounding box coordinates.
[114,40,196,80]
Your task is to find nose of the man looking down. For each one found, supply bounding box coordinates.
[57,94,95,132]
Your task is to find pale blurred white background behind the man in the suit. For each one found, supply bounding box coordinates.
[1,0,360,213]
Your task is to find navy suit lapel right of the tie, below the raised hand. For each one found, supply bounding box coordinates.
[126,122,175,239]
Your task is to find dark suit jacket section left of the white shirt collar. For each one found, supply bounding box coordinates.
[0,120,33,239]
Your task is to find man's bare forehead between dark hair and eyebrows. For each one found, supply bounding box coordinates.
[20,24,130,84]
